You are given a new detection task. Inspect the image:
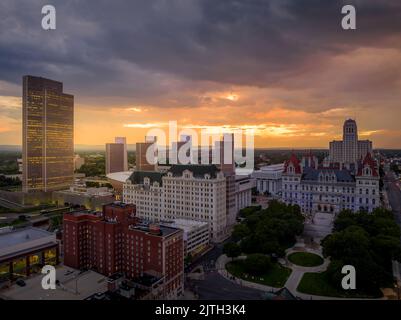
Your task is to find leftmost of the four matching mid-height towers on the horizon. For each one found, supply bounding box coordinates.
[106,137,128,174]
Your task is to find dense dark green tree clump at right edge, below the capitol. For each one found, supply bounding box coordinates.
[322,208,401,292]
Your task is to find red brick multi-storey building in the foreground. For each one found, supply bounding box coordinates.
[64,203,184,299]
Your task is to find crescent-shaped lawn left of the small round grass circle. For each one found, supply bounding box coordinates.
[226,260,291,288]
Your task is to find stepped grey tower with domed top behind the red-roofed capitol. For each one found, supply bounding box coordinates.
[329,119,372,164]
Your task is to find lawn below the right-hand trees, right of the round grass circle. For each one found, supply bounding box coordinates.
[297,272,383,298]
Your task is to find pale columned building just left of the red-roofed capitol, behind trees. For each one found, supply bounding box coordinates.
[252,163,284,196]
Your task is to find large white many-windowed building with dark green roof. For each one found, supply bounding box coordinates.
[123,165,229,242]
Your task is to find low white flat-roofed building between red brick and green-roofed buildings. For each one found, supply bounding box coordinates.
[160,219,210,257]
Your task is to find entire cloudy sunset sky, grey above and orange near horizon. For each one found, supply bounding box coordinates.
[0,0,401,148]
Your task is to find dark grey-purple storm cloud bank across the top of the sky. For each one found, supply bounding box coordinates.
[0,0,401,101]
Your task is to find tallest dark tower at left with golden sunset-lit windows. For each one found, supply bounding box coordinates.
[22,76,74,192]
